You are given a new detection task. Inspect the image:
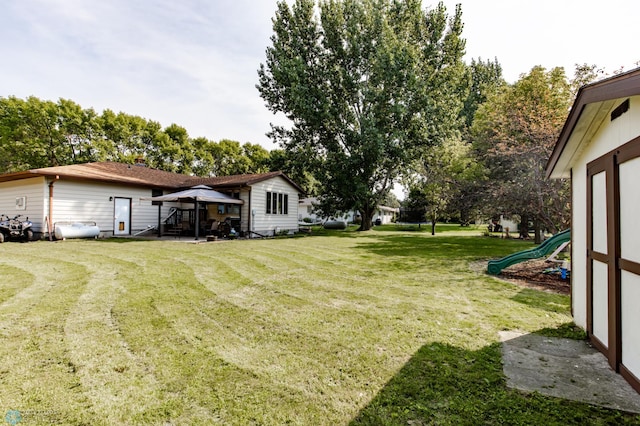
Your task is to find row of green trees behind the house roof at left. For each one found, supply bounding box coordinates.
[0,97,276,176]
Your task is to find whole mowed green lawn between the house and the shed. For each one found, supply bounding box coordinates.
[0,225,640,425]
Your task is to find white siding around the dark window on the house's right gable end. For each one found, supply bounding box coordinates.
[250,176,299,235]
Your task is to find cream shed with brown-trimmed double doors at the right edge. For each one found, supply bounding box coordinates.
[547,68,640,392]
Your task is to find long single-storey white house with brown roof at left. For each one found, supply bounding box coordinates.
[0,162,303,236]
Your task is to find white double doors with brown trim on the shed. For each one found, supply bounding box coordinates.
[587,137,640,392]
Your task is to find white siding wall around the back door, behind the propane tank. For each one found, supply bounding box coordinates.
[46,180,169,236]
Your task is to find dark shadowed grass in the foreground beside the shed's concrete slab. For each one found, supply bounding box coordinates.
[350,332,640,426]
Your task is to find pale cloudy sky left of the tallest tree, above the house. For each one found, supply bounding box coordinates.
[0,0,282,147]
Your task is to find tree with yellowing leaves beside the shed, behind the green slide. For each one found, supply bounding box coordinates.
[473,67,572,241]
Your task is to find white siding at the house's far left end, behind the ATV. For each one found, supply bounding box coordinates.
[0,177,48,232]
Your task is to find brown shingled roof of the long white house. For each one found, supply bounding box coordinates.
[0,161,304,193]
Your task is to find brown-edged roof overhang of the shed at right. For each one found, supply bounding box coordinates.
[546,68,640,178]
